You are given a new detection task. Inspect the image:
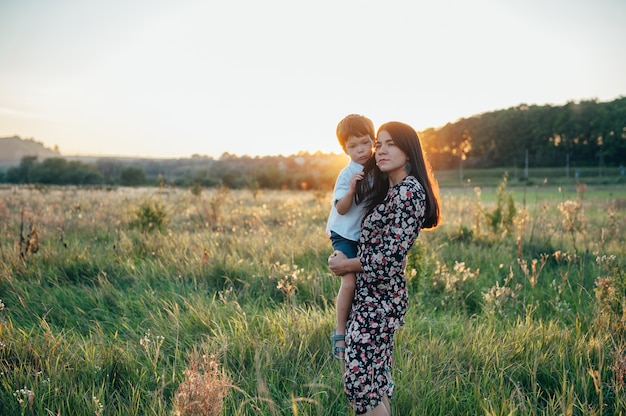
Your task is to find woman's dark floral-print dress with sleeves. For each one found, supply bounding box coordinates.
[344,176,426,414]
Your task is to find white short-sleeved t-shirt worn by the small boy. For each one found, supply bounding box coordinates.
[326,160,364,241]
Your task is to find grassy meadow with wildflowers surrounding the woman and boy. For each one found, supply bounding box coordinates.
[0,172,626,416]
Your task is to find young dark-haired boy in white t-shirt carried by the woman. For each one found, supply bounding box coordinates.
[326,114,376,360]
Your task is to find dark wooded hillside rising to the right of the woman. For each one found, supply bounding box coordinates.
[420,97,626,169]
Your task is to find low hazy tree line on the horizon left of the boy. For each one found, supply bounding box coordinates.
[0,152,348,190]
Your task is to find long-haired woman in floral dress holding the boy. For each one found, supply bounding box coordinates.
[328,122,440,416]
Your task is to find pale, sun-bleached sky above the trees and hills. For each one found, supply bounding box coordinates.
[0,0,626,158]
